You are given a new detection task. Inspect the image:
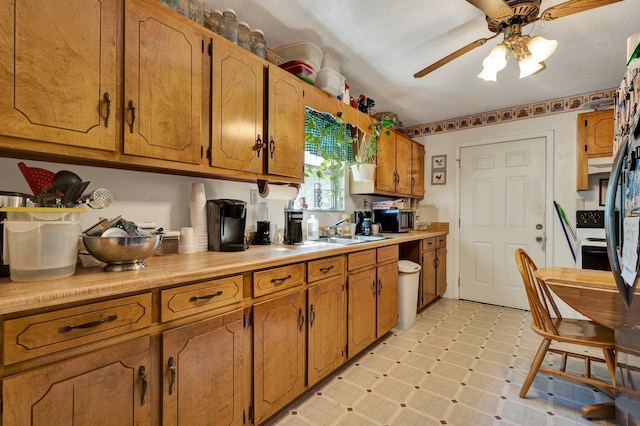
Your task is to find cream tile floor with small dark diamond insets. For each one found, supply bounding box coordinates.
[267,299,615,426]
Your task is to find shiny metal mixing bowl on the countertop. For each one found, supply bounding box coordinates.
[82,234,162,271]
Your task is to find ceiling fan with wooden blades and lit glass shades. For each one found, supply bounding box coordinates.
[413,0,622,81]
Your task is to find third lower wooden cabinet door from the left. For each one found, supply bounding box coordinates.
[253,291,307,424]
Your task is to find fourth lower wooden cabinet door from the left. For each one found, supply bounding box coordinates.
[307,276,347,386]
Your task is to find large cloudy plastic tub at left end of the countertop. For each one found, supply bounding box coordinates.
[2,207,84,282]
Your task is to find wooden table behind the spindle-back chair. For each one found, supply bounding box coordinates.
[536,267,640,419]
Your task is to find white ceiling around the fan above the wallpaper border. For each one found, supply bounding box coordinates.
[205,0,640,127]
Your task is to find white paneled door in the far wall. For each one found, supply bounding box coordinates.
[460,138,546,309]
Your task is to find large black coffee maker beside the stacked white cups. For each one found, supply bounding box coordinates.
[207,199,249,251]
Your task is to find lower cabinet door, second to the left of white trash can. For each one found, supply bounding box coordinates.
[347,268,378,358]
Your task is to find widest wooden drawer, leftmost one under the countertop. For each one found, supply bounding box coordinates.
[3,293,151,365]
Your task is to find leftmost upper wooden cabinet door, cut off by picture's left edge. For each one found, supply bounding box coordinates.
[0,0,120,151]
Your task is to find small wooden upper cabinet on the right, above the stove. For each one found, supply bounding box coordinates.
[576,109,614,191]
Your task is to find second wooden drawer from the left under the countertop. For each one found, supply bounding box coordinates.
[160,275,243,321]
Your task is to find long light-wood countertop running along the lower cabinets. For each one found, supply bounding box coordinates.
[0,229,447,315]
